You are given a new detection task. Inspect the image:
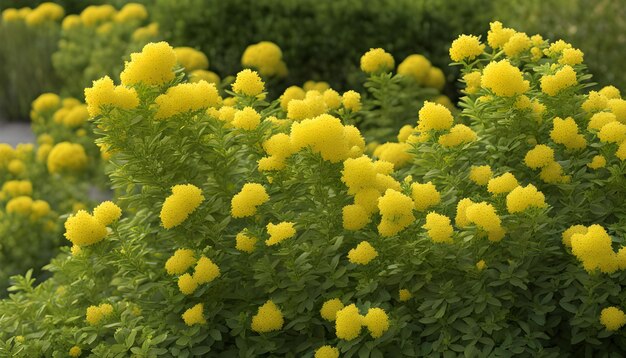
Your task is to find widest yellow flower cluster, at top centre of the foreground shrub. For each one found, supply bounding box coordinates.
[290,114,365,163]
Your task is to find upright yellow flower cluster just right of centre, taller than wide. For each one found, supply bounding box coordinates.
[378,189,415,237]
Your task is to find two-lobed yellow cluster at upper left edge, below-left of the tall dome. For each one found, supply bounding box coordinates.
[85,76,139,116]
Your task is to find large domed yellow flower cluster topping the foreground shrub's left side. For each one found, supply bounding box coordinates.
[120,41,176,86]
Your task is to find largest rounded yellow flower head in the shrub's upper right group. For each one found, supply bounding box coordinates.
[481,60,530,97]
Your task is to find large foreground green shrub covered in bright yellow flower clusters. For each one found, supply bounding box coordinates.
[0,22,626,357]
